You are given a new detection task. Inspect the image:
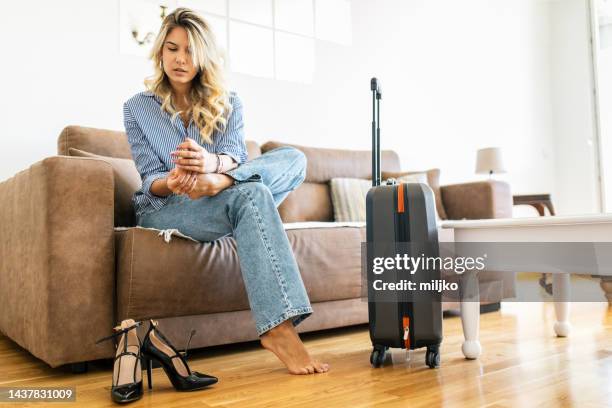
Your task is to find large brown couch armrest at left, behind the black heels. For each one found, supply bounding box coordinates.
[0,156,115,367]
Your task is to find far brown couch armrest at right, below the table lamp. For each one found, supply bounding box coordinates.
[440,180,512,220]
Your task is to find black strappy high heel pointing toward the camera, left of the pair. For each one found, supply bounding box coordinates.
[96,319,143,404]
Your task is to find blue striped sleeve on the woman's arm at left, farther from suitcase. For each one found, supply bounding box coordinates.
[123,105,169,209]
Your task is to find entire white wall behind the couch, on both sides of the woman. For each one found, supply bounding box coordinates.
[0,0,596,217]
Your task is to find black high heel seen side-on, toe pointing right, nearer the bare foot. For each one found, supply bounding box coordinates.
[142,320,219,391]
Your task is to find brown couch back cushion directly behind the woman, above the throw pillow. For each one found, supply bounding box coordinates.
[57,126,261,160]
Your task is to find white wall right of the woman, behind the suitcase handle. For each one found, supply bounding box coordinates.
[234,0,554,192]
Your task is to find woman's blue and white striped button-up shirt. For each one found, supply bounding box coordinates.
[123,91,247,217]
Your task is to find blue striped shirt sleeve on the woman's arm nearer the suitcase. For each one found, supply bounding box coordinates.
[216,92,248,164]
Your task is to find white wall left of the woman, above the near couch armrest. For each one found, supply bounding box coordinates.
[0,0,136,175]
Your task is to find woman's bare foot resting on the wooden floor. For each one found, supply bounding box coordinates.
[260,320,329,374]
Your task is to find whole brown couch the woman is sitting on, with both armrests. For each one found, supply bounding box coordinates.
[0,126,514,367]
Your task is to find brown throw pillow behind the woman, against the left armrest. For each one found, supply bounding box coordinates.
[68,147,142,227]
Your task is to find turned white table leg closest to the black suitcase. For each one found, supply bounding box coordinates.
[461,272,482,360]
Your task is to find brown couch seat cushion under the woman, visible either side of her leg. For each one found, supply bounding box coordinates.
[115,227,365,320]
